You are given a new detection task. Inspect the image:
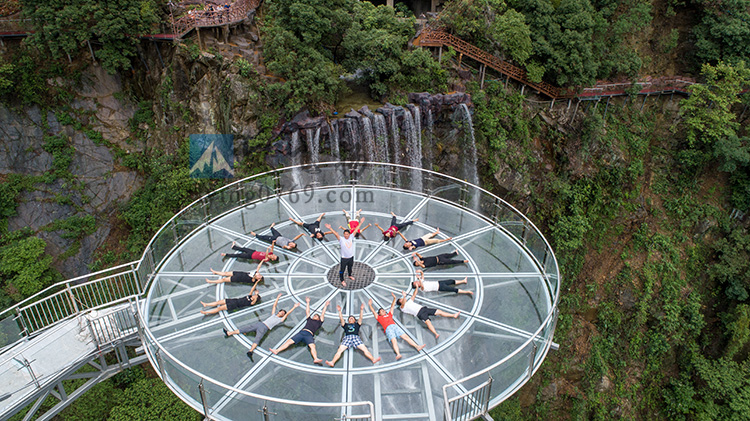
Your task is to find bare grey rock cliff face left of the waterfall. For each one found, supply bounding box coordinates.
[0,67,142,276]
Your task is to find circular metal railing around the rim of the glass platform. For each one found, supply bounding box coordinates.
[136,162,560,419]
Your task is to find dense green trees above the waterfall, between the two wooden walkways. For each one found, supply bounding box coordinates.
[263,0,447,112]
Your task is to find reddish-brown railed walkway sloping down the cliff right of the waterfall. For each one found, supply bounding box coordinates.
[414,28,695,100]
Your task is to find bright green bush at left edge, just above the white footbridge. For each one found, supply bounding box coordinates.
[0,237,56,301]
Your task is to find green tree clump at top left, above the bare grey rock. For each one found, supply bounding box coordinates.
[23,0,159,73]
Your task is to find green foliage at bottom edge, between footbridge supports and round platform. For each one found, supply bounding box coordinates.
[108,379,201,421]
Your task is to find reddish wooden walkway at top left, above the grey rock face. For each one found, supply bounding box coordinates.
[0,0,262,41]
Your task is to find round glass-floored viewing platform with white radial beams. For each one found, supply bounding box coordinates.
[139,163,559,420]
